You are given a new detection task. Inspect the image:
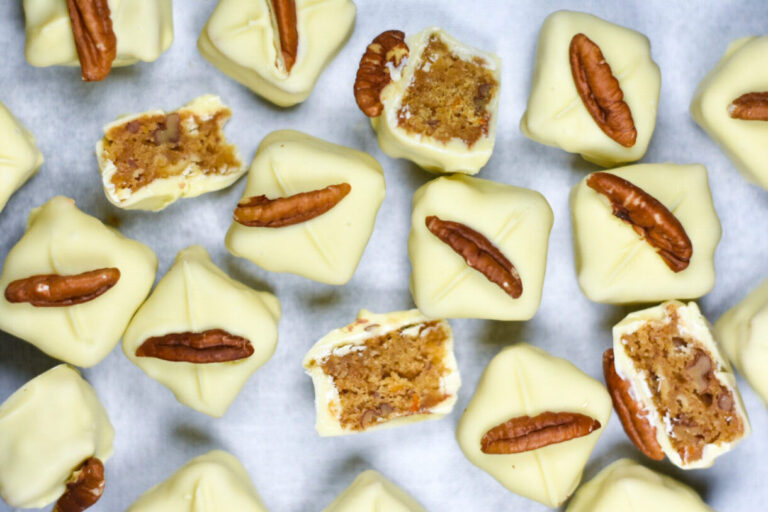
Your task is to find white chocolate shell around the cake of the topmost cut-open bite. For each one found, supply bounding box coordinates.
[371,27,501,174]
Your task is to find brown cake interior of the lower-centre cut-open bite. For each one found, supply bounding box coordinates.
[320,322,449,430]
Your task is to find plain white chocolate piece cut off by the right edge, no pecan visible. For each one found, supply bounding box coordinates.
[715,279,768,405]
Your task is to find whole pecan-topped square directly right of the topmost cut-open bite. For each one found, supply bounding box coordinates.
[520,11,661,167]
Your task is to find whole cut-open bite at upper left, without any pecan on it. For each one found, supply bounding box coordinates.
[96,94,245,211]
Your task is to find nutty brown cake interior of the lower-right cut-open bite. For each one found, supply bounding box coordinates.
[621,306,744,463]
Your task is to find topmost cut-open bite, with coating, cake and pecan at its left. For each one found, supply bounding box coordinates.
[354,28,501,174]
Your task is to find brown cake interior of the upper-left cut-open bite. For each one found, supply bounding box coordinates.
[104,109,240,192]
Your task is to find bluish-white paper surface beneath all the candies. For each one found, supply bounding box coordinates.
[0,0,768,512]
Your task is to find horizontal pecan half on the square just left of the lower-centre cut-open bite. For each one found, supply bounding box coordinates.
[136,329,253,364]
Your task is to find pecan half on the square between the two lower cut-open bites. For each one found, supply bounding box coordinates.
[480,412,600,455]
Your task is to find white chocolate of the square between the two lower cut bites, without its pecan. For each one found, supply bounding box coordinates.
[456,343,611,508]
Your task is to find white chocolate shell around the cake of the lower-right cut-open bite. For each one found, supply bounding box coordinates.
[613,301,751,469]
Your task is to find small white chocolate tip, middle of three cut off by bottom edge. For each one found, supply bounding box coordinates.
[323,469,426,512]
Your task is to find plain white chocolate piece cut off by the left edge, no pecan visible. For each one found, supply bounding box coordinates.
[0,103,43,213]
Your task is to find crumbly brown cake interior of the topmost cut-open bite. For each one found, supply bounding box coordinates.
[397,35,498,147]
